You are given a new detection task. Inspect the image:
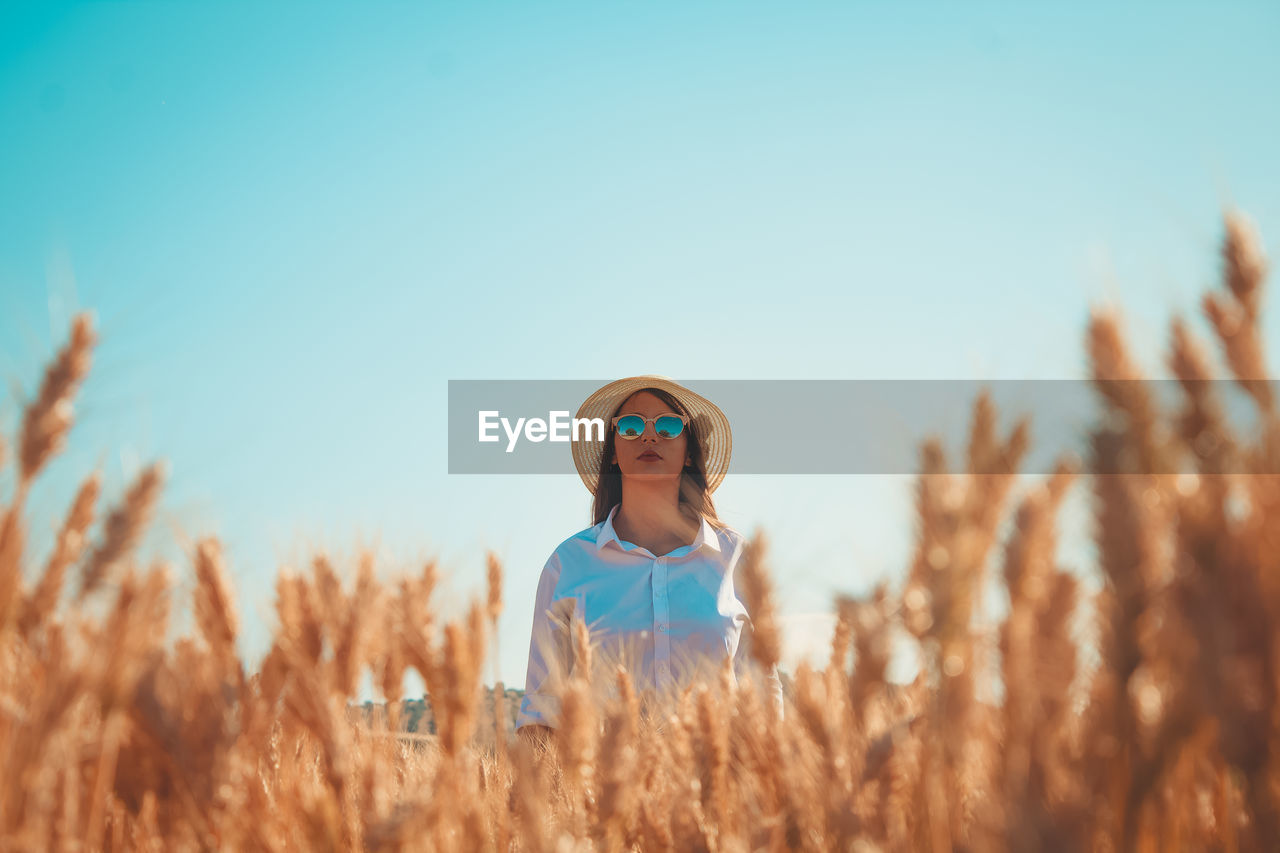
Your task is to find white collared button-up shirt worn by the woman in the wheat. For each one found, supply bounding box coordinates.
[516,505,782,729]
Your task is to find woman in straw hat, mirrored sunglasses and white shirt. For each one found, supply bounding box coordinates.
[516,375,782,739]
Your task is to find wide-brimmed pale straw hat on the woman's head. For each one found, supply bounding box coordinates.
[570,374,733,494]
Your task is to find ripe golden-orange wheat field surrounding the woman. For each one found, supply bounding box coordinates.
[0,211,1280,850]
